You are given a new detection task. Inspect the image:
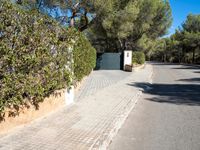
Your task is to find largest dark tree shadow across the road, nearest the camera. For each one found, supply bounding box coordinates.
[128,83,200,106]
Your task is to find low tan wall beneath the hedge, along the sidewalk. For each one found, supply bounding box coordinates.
[0,90,66,134]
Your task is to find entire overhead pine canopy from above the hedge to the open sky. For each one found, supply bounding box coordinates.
[16,0,172,51]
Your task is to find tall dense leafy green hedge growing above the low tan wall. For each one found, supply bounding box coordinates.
[0,0,95,119]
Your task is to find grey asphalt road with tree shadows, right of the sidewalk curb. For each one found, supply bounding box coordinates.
[109,63,200,150]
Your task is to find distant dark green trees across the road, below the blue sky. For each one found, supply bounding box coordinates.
[154,14,200,63]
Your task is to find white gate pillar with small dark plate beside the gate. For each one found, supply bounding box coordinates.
[124,50,133,71]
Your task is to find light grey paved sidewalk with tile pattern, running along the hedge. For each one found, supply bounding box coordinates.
[0,65,152,150]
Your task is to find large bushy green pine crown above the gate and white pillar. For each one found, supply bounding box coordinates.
[91,0,172,50]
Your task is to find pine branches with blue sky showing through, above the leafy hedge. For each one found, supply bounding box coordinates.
[14,0,94,31]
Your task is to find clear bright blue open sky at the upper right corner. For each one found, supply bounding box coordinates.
[168,0,200,35]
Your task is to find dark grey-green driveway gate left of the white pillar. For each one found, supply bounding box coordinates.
[95,53,123,70]
